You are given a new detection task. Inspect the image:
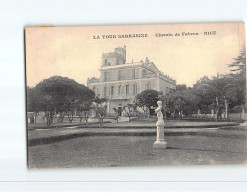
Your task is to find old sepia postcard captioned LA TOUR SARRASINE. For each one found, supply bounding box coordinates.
[25,22,247,168]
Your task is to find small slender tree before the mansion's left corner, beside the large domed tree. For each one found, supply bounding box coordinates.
[93,97,107,126]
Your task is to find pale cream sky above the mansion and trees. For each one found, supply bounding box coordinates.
[25,23,245,87]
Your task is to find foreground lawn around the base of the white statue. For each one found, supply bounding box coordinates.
[28,127,246,168]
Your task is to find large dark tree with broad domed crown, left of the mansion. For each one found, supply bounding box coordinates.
[27,76,94,125]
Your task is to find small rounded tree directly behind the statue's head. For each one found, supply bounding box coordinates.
[135,89,161,118]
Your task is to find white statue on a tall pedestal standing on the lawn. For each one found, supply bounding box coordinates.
[153,101,166,148]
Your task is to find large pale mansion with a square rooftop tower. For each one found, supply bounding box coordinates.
[87,46,176,113]
